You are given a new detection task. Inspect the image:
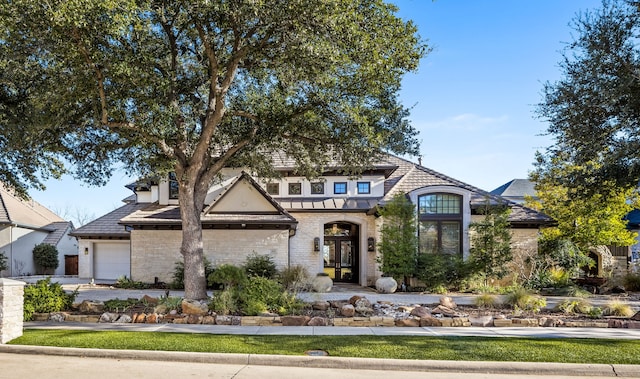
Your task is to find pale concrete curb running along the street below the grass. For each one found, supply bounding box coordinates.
[0,345,640,377]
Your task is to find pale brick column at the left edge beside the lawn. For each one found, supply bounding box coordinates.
[0,278,26,344]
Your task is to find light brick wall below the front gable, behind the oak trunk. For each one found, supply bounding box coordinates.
[131,229,289,283]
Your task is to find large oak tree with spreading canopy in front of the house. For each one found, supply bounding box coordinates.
[0,0,428,299]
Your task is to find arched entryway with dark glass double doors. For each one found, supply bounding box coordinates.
[322,222,360,283]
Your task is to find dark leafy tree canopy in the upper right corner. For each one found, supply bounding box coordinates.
[536,0,640,197]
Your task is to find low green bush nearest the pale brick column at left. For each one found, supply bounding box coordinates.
[23,278,78,321]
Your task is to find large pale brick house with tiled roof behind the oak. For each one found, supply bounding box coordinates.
[73,155,551,285]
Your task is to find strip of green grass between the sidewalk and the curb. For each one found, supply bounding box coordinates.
[10,329,640,364]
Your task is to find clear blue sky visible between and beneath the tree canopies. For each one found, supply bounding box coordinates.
[31,0,601,227]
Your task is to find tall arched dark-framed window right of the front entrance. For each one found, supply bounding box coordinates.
[418,193,462,254]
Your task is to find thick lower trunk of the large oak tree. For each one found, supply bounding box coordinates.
[179,185,207,300]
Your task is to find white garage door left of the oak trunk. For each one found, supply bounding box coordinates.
[93,242,131,280]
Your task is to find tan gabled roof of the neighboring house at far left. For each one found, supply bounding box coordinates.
[0,184,65,229]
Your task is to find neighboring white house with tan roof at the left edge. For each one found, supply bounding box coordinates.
[0,185,78,277]
